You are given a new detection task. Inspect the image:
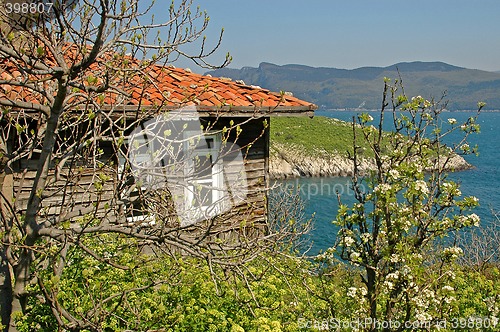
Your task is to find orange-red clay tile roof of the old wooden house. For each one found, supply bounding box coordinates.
[0,46,317,115]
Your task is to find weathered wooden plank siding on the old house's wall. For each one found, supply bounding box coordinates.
[5,117,269,240]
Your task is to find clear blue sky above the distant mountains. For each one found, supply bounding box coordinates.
[173,0,500,72]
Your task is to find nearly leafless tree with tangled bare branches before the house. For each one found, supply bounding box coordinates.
[0,0,304,331]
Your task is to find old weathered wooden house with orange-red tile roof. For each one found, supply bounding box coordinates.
[0,52,316,244]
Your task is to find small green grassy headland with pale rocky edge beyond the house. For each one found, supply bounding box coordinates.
[269,116,472,179]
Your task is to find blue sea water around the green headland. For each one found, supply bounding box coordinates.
[282,110,500,255]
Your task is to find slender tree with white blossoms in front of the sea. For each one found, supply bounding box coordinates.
[324,79,484,330]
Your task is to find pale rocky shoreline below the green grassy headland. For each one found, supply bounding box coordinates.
[269,144,473,180]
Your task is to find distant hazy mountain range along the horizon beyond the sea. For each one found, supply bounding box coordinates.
[207,62,500,110]
